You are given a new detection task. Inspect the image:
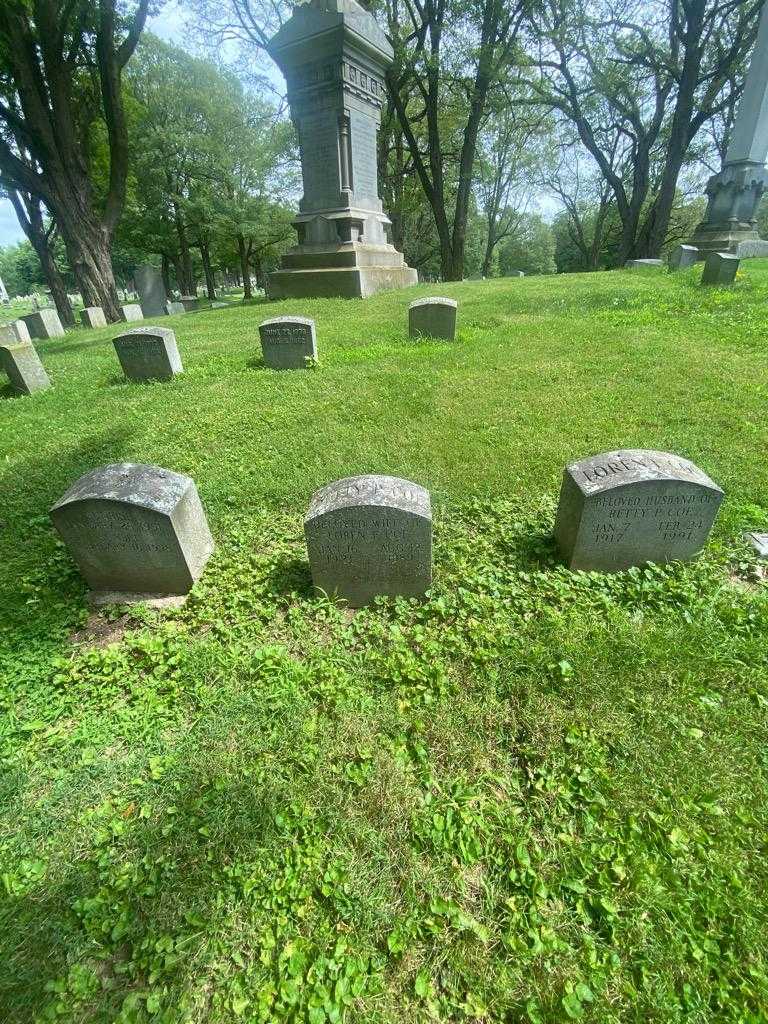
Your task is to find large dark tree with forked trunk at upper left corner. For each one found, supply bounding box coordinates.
[0,0,150,321]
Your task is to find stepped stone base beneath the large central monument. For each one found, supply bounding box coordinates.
[266,242,419,299]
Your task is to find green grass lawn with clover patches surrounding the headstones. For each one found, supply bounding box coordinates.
[0,261,768,1024]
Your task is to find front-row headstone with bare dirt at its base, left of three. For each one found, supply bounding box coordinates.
[50,462,214,601]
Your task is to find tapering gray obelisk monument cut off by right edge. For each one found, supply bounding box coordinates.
[691,4,768,259]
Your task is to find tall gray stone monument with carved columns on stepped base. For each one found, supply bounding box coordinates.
[267,0,417,299]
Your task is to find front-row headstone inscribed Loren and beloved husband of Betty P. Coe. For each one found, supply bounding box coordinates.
[555,449,723,572]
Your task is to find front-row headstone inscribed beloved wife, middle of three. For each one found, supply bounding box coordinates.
[304,476,432,608]
